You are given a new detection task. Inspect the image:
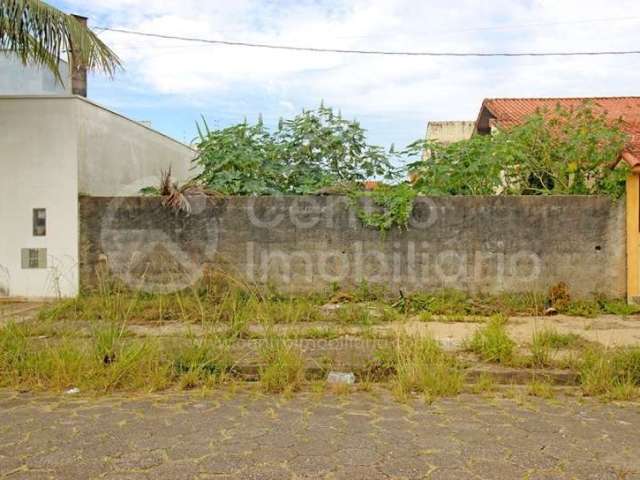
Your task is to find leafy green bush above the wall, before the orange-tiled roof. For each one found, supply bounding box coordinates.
[404,102,627,197]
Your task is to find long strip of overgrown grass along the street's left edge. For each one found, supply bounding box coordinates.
[0,323,230,393]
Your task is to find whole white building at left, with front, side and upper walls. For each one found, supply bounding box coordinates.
[0,56,194,298]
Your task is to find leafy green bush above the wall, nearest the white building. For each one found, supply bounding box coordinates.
[194,105,397,195]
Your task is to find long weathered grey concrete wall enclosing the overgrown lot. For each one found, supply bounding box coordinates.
[80,196,626,297]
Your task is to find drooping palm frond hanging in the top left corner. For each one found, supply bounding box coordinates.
[0,0,121,83]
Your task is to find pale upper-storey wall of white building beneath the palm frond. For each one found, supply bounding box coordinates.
[0,51,71,95]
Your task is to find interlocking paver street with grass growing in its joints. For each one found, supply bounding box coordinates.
[0,387,640,480]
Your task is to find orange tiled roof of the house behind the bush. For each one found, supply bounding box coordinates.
[475,97,640,168]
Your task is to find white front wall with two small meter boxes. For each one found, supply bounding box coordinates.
[0,98,78,297]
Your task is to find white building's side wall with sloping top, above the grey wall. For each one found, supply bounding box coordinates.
[77,99,195,196]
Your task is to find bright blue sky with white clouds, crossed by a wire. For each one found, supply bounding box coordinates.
[50,0,640,146]
